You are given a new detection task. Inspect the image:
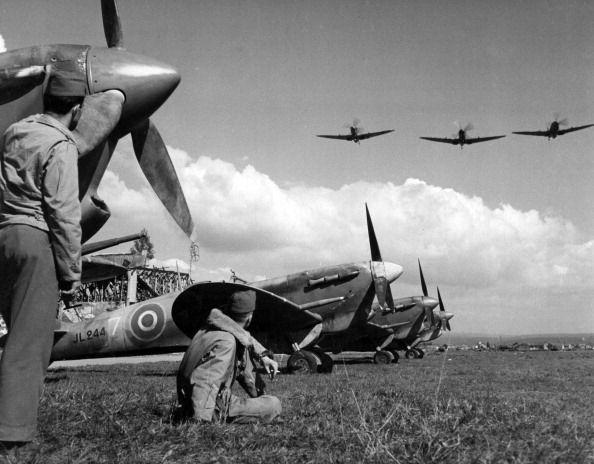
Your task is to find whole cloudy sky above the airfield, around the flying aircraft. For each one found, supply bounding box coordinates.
[0,0,594,335]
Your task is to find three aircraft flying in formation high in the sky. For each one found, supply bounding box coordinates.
[316,115,594,148]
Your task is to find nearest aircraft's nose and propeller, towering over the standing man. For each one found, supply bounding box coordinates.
[0,0,193,242]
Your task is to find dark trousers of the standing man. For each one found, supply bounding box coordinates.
[0,225,58,441]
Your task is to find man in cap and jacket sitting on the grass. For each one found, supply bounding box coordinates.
[177,290,281,423]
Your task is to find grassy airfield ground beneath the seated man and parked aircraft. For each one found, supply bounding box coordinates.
[32,351,594,463]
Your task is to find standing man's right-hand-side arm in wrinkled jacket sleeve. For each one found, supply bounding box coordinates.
[42,141,82,289]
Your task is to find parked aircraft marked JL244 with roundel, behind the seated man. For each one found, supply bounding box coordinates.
[52,206,402,372]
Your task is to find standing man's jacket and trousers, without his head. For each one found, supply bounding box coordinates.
[0,114,81,441]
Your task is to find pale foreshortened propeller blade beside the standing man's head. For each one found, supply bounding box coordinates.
[72,90,124,156]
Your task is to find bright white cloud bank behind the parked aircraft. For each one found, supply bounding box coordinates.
[100,149,594,331]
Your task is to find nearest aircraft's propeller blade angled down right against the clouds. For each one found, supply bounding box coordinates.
[132,119,194,237]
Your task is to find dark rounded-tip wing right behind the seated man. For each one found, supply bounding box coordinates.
[171,282,322,338]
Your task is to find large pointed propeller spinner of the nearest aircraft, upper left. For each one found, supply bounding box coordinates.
[87,47,181,134]
